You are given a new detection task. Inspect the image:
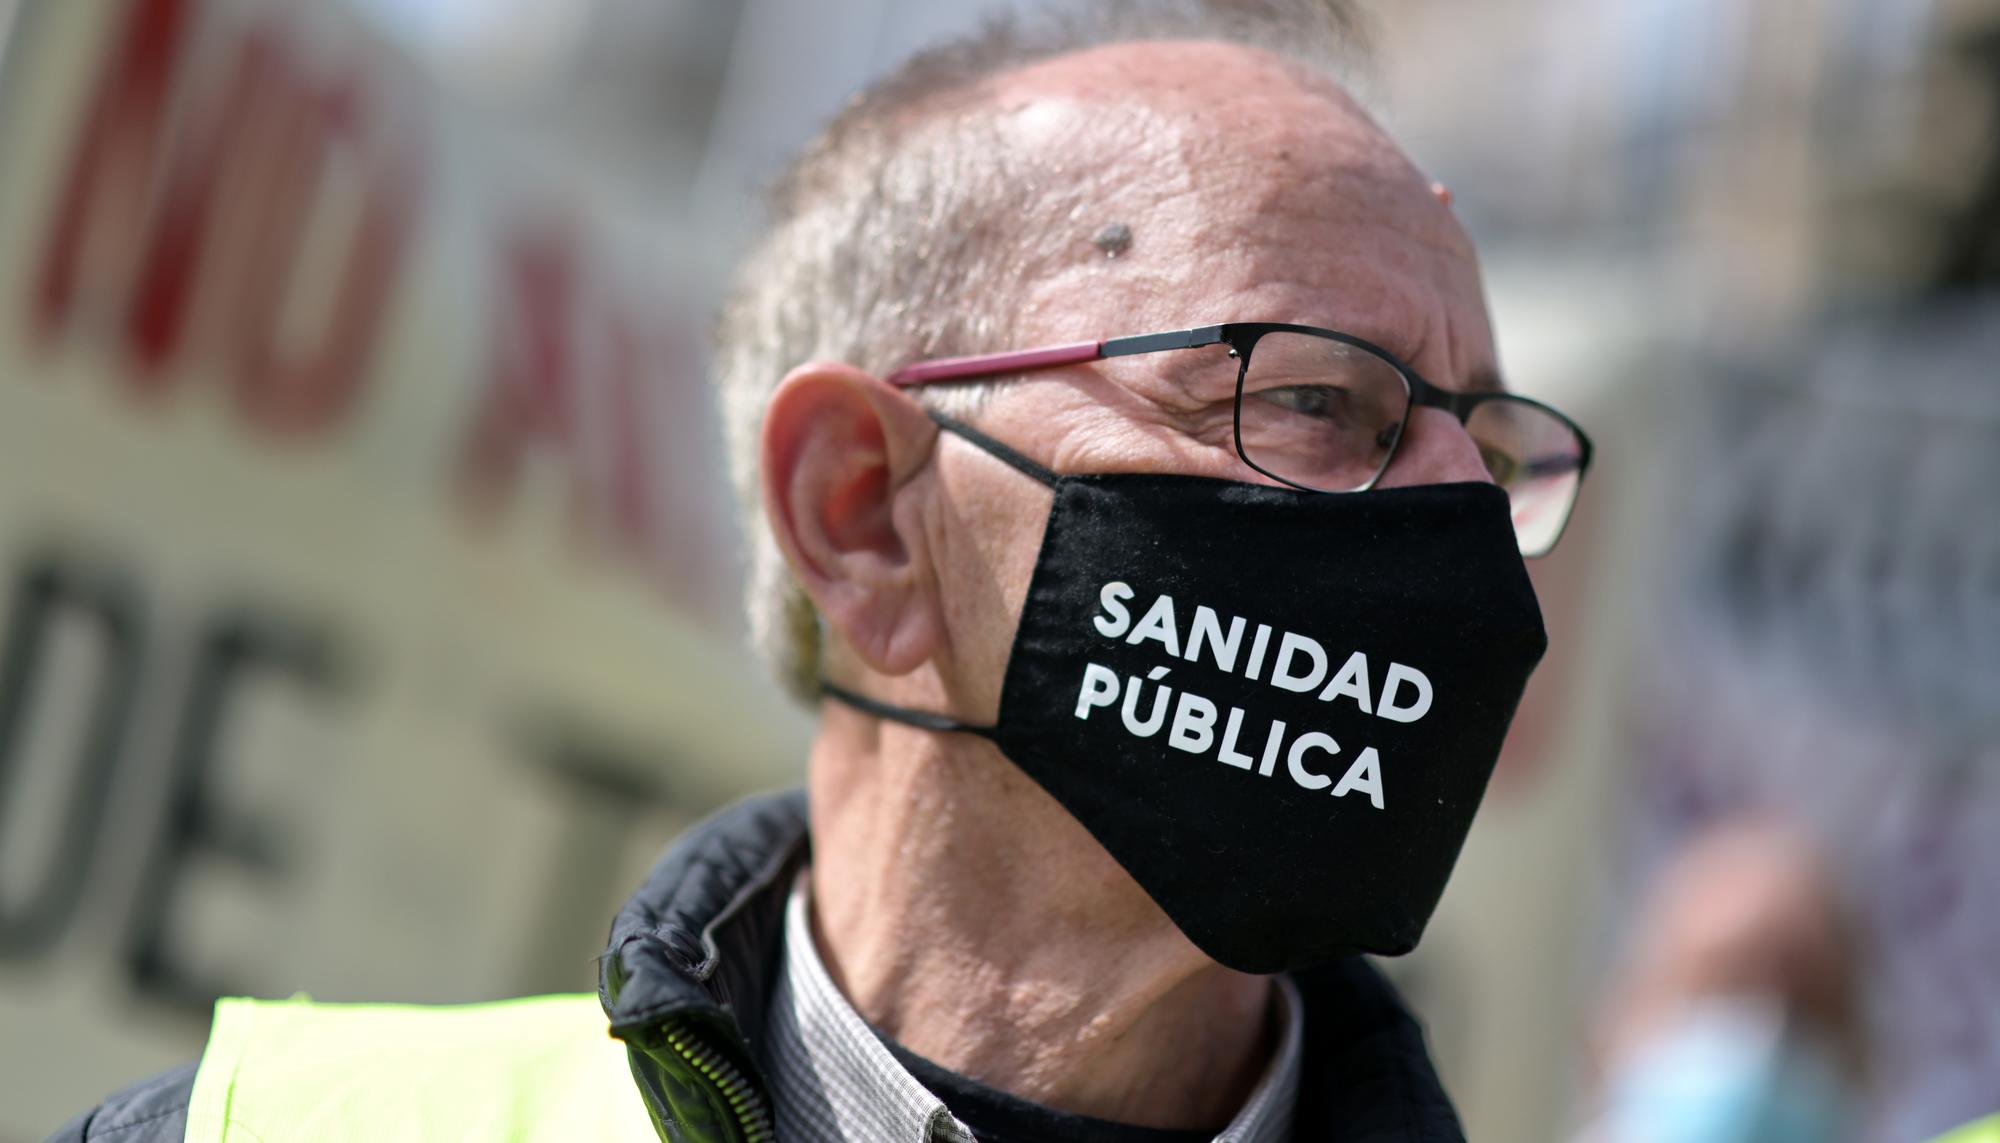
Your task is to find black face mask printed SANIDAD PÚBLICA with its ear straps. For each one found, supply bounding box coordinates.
[826,416,1548,973]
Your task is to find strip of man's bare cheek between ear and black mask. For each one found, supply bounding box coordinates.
[928,450,1052,715]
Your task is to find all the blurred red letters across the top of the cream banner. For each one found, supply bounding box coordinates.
[21,0,720,613]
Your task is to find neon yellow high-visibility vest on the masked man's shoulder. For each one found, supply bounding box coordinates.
[186,995,660,1143]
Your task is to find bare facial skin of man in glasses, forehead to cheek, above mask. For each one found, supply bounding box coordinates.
[924,44,1496,717]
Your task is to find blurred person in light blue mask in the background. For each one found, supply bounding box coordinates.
[1582,817,1866,1143]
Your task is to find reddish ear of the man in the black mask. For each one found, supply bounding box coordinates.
[760,362,944,675]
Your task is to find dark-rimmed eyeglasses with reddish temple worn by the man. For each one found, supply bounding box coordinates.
[888,322,1590,558]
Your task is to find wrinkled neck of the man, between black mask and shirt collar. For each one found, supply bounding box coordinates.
[810,703,1270,1129]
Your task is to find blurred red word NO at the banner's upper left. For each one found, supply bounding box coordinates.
[36,0,414,440]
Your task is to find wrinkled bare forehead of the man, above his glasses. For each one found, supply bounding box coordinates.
[994,42,1492,386]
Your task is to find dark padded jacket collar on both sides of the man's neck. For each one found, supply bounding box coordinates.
[598,791,1464,1143]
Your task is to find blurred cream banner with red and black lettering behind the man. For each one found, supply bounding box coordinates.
[0,0,802,1139]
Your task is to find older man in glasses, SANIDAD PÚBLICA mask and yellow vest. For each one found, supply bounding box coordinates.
[54,6,1588,1143]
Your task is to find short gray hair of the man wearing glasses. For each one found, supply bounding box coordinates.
[716,0,1358,701]
